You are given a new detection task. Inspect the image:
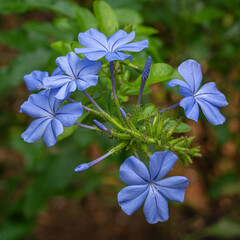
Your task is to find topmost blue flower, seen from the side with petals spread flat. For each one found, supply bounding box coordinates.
[75,28,148,62]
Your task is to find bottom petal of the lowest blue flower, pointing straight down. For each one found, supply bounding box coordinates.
[143,187,169,224]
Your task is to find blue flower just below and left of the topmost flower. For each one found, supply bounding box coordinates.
[43,52,101,100]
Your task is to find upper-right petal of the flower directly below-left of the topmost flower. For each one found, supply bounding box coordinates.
[77,58,101,78]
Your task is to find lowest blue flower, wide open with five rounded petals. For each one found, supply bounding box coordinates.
[118,151,189,224]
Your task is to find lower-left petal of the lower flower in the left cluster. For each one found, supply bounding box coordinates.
[21,117,51,143]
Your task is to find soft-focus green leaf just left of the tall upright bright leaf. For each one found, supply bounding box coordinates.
[76,7,97,32]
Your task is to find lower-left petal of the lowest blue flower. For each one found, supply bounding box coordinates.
[118,184,149,215]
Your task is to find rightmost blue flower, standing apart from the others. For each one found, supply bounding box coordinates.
[167,59,228,125]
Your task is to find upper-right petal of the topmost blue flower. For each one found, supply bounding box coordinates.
[108,30,135,52]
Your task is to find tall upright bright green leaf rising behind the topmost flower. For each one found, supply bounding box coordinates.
[93,1,118,37]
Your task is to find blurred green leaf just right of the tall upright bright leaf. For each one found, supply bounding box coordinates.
[114,8,143,27]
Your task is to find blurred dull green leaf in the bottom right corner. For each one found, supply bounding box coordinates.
[203,218,240,239]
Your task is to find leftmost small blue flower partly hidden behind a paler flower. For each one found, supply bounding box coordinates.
[23,67,64,94]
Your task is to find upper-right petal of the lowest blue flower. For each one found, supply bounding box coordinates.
[149,150,178,181]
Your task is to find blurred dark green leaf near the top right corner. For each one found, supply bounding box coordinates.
[193,6,224,23]
